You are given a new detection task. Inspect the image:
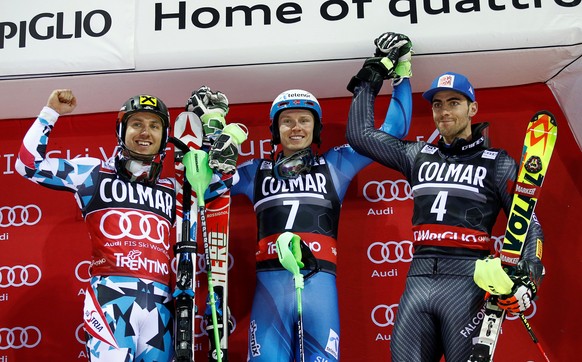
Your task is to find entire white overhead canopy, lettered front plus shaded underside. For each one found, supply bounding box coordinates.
[0,0,582,150]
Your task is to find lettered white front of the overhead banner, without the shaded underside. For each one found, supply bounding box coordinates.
[0,0,582,79]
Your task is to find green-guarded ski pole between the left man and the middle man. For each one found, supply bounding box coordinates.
[183,150,222,362]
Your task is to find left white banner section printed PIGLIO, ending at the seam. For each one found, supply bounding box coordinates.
[0,0,135,79]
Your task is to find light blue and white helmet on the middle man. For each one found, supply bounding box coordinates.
[270,89,323,145]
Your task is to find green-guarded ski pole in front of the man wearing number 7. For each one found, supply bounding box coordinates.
[277,232,305,362]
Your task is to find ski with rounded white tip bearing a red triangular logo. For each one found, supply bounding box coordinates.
[170,112,203,362]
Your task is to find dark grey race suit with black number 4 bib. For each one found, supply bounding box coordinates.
[347,82,543,362]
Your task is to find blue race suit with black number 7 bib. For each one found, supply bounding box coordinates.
[232,80,412,362]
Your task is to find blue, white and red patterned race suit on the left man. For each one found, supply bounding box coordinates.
[16,107,175,362]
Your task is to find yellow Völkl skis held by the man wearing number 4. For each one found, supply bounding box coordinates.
[469,111,558,362]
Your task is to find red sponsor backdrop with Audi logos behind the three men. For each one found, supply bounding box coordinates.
[0,84,582,362]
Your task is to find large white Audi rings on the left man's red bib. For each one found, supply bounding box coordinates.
[99,210,170,250]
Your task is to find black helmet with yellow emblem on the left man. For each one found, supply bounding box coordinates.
[116,94,170,156]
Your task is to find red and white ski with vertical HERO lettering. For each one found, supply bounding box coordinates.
[204,181,234,362]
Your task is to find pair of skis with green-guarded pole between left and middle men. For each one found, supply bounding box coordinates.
[170,112,230,362]
